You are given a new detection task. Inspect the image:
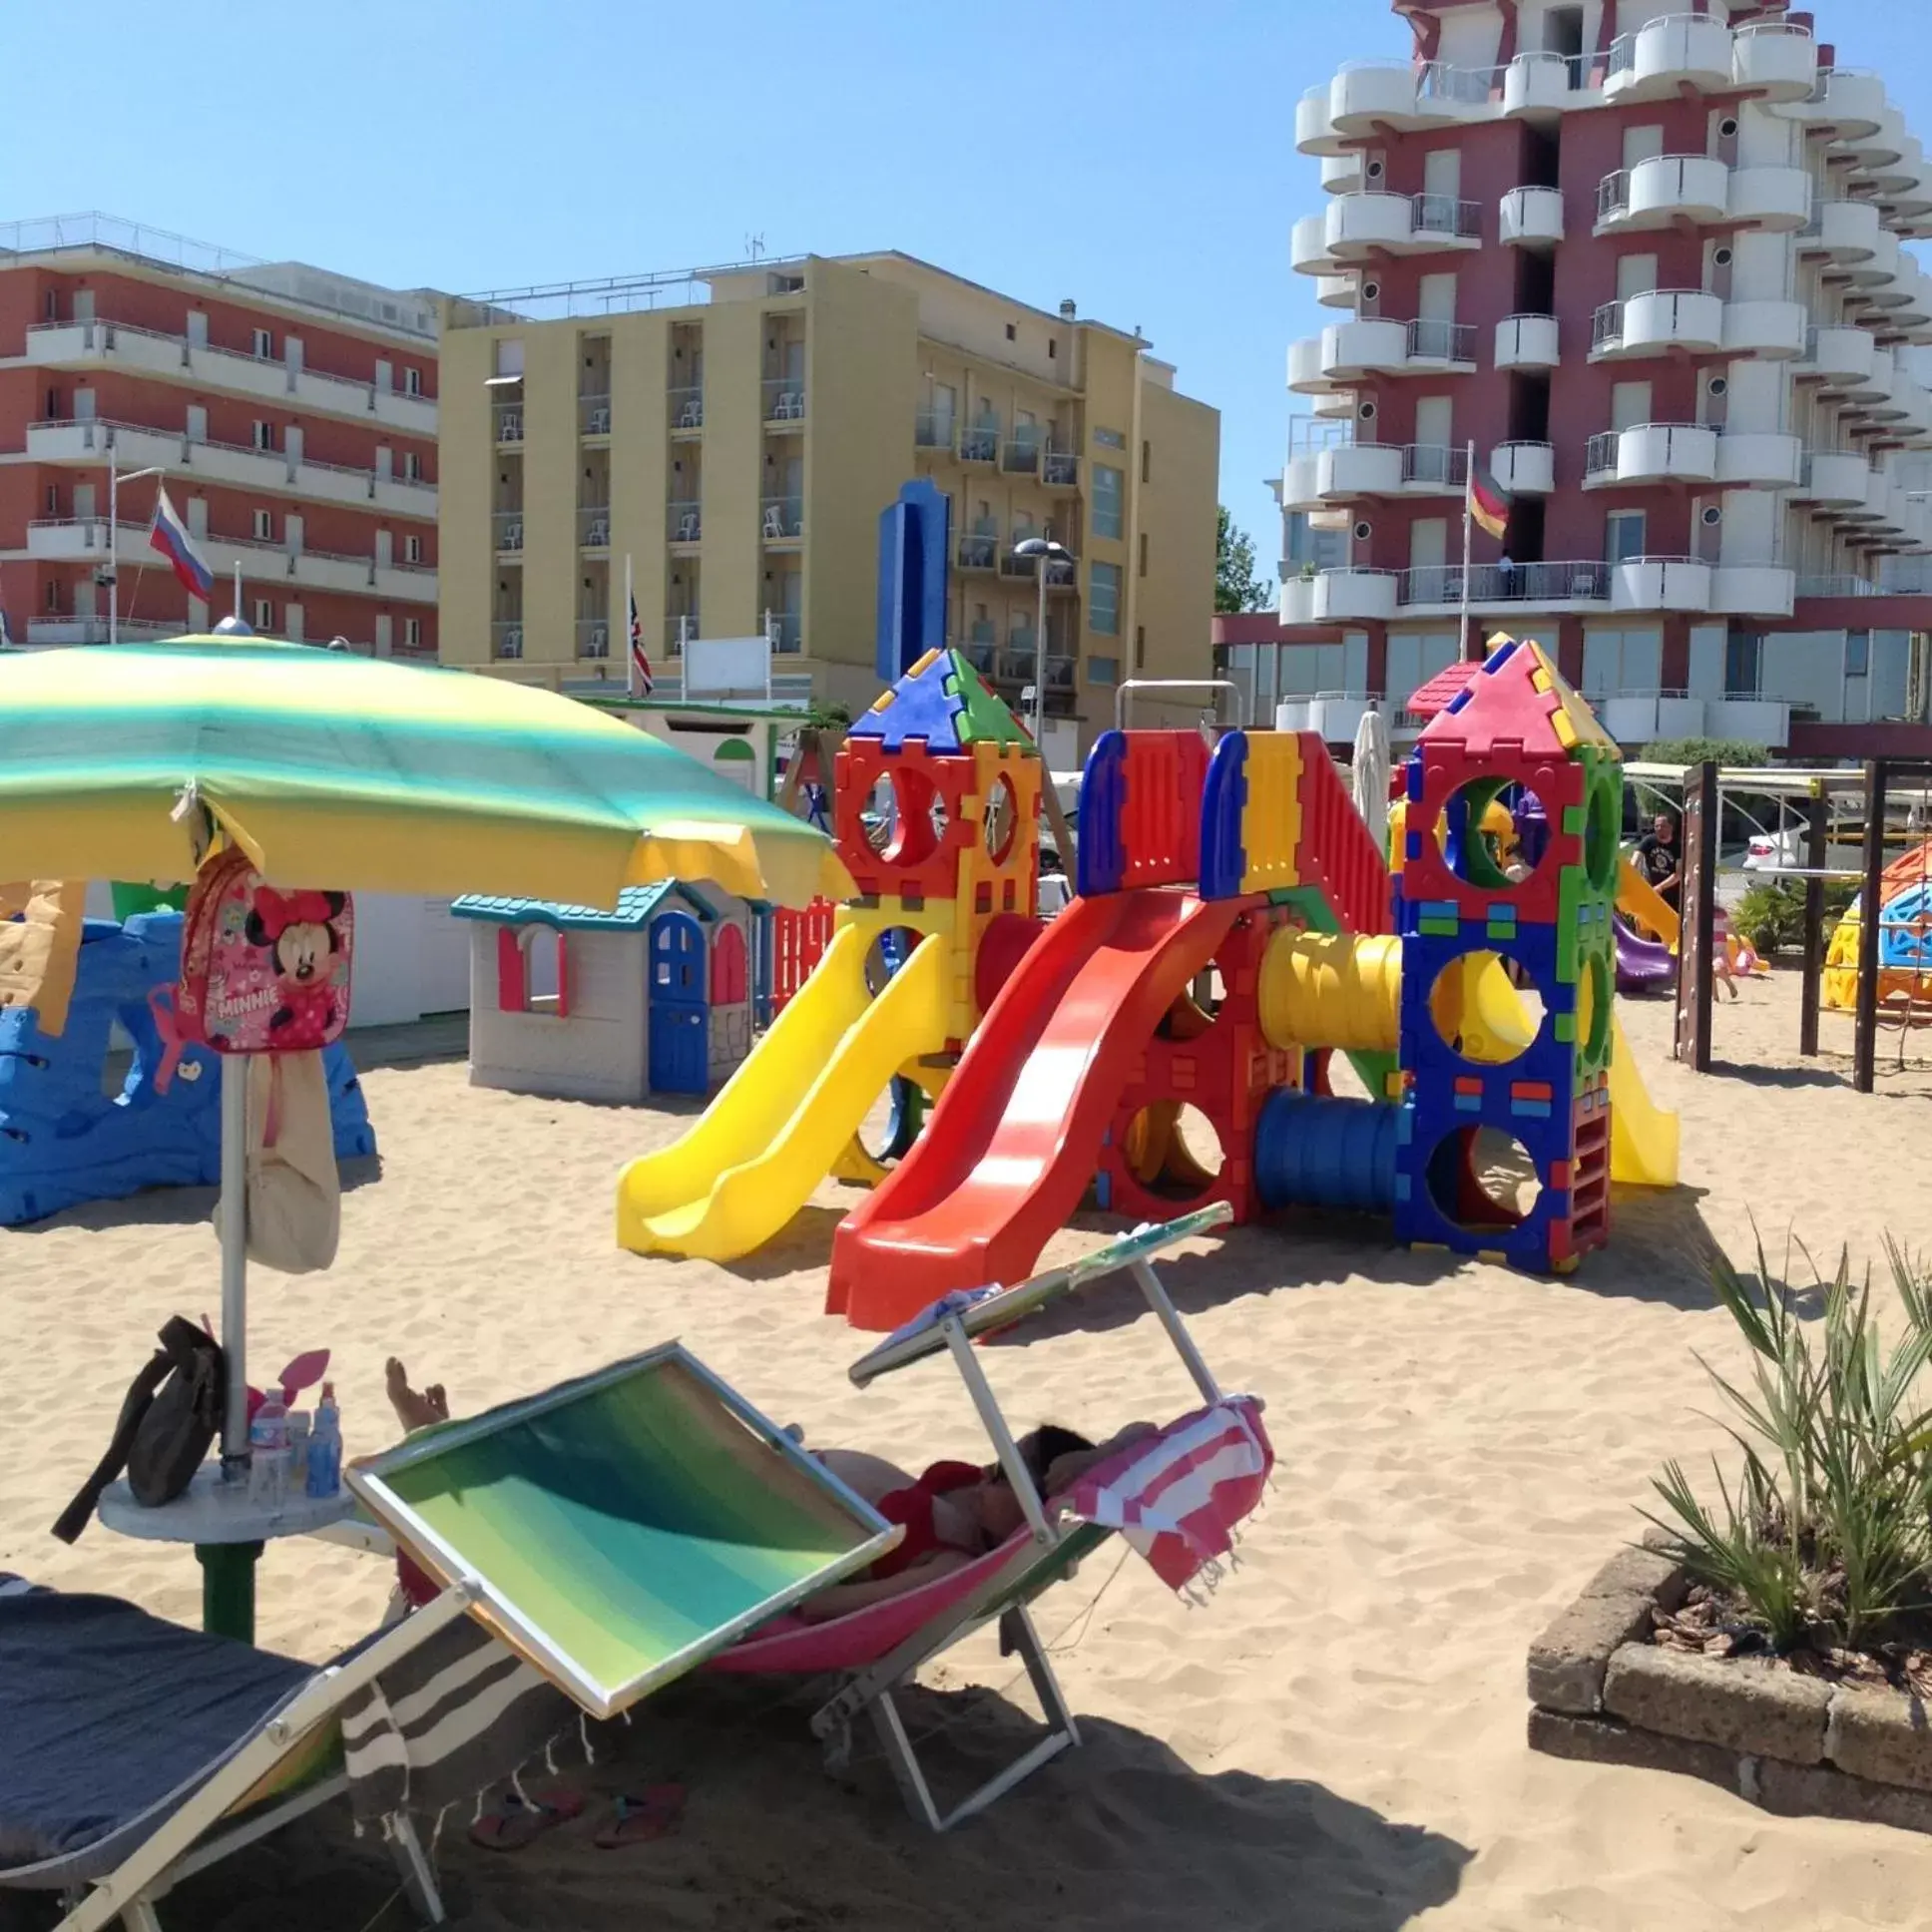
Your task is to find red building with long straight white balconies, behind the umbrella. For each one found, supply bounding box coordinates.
[0,215,438,655]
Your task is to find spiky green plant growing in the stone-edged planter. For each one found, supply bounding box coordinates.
[1645,1242,1932,1650]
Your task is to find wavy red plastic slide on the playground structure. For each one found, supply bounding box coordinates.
[825,887,1240,1329]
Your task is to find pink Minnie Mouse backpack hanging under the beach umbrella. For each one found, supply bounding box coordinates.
[176,848,355,1053]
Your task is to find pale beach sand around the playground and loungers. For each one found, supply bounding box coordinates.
[0,974,1932,1932]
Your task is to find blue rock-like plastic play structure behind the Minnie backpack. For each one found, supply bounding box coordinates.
[0,912,375,1226]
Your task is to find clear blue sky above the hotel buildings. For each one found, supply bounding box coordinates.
[0,0,1932,562]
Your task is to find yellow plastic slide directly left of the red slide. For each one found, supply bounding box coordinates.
[617,925,947,1261]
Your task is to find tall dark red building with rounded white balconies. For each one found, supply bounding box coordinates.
[1219,0,1932,757]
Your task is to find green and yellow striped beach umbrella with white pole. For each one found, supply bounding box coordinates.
[0,636,852,1455]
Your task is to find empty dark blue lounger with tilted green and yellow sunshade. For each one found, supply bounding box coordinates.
[0,1344,898,1932]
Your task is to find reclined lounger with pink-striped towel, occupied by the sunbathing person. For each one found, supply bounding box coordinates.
[708,1204,1273,1831]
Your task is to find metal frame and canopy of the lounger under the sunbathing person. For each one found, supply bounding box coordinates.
[811,1202,1232,1831]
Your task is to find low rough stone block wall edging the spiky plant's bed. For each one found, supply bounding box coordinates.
[1528,1548,1932,1831]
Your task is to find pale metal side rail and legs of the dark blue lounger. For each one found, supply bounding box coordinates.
[43,1586,473,1932]
